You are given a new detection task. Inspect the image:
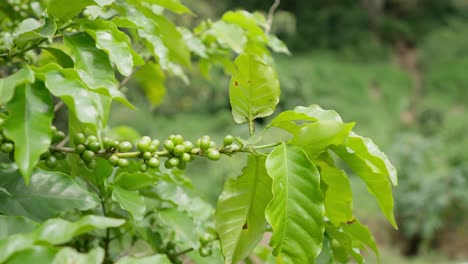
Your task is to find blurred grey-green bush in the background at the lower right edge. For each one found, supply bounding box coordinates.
[391,133,468,251]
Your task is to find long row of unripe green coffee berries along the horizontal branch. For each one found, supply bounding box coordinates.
[70,133,240,172]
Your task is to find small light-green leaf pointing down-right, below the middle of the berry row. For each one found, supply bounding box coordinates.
[112,186,146,221]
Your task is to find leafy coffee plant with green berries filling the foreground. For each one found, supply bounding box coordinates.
[0,0,397,264]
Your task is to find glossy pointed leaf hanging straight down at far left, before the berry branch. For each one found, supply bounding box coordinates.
[4,82,54,183]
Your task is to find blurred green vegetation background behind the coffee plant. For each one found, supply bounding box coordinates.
[110,0,468,263]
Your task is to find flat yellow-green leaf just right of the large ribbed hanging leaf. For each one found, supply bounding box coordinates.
[317,162,353,226]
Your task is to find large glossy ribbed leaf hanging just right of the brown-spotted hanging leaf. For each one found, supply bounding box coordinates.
[266,143,324,263]
